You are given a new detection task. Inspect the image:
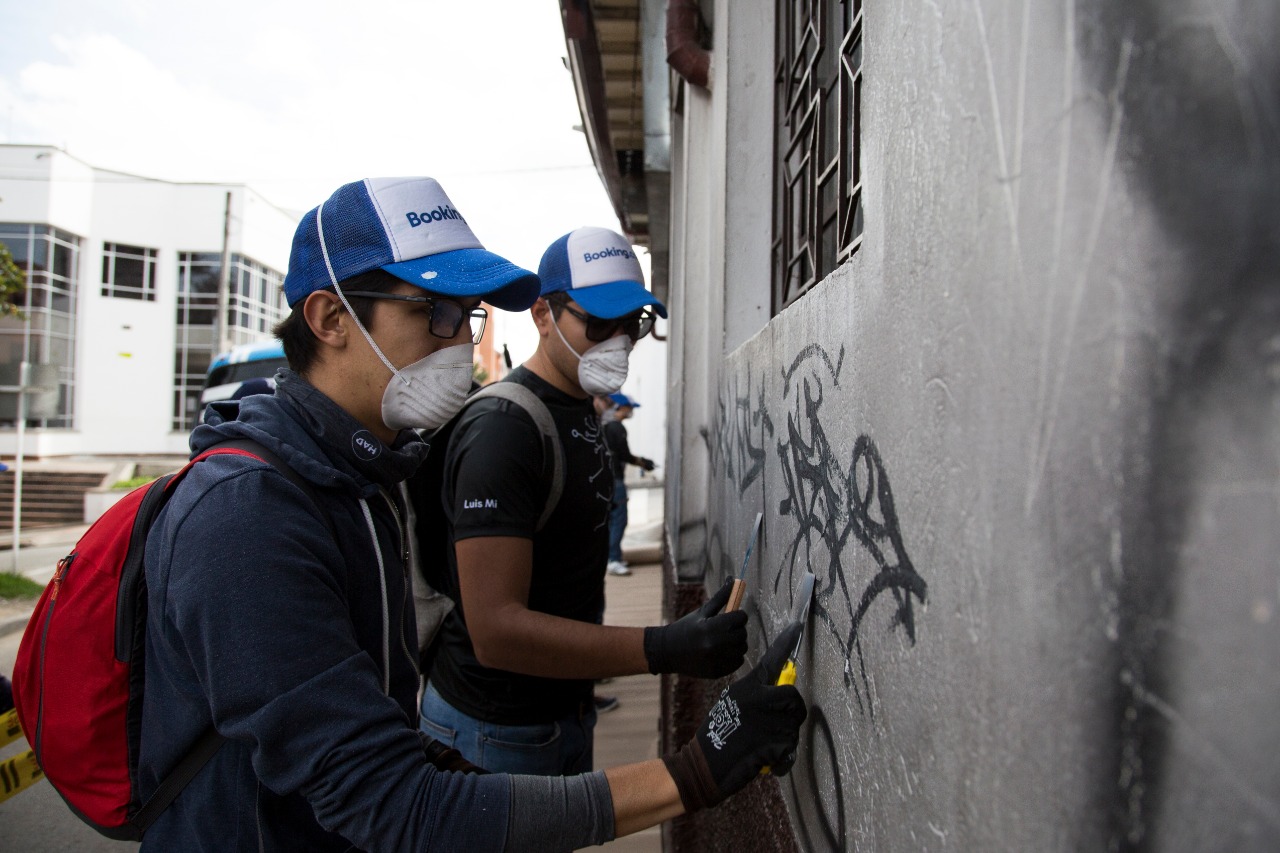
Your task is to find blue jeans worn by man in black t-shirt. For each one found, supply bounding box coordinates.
[419,681,595,776]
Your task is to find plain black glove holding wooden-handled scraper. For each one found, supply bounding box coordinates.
[644,578,746,679]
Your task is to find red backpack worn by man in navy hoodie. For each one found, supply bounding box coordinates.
[13,439,316,840]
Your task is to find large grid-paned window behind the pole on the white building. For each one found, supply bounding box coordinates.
[173,252,288,430]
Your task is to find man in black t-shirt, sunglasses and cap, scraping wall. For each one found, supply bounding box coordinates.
[421,228,746,775]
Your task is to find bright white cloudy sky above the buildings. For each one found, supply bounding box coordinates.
[0,0,624,361]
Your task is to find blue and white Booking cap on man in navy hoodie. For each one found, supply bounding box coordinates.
[284,178,539,311]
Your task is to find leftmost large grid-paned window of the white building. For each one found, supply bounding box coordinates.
[0,224,81,429]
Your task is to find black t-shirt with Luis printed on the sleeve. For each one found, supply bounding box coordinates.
[431,366,613,725]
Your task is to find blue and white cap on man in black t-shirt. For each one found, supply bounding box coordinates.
[538,225,667,320]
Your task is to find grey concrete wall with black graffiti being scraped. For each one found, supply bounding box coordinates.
[667,0,1280,850]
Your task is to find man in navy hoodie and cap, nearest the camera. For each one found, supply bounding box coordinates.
[138,178,805,852]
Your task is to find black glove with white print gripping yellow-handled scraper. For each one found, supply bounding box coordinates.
[662,622,809,812]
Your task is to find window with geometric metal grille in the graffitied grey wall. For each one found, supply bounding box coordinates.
[773,0,863,314]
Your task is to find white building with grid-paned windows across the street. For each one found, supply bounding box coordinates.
[0,145,301,457]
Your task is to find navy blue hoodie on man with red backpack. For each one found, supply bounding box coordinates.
[140,371,514,853]
